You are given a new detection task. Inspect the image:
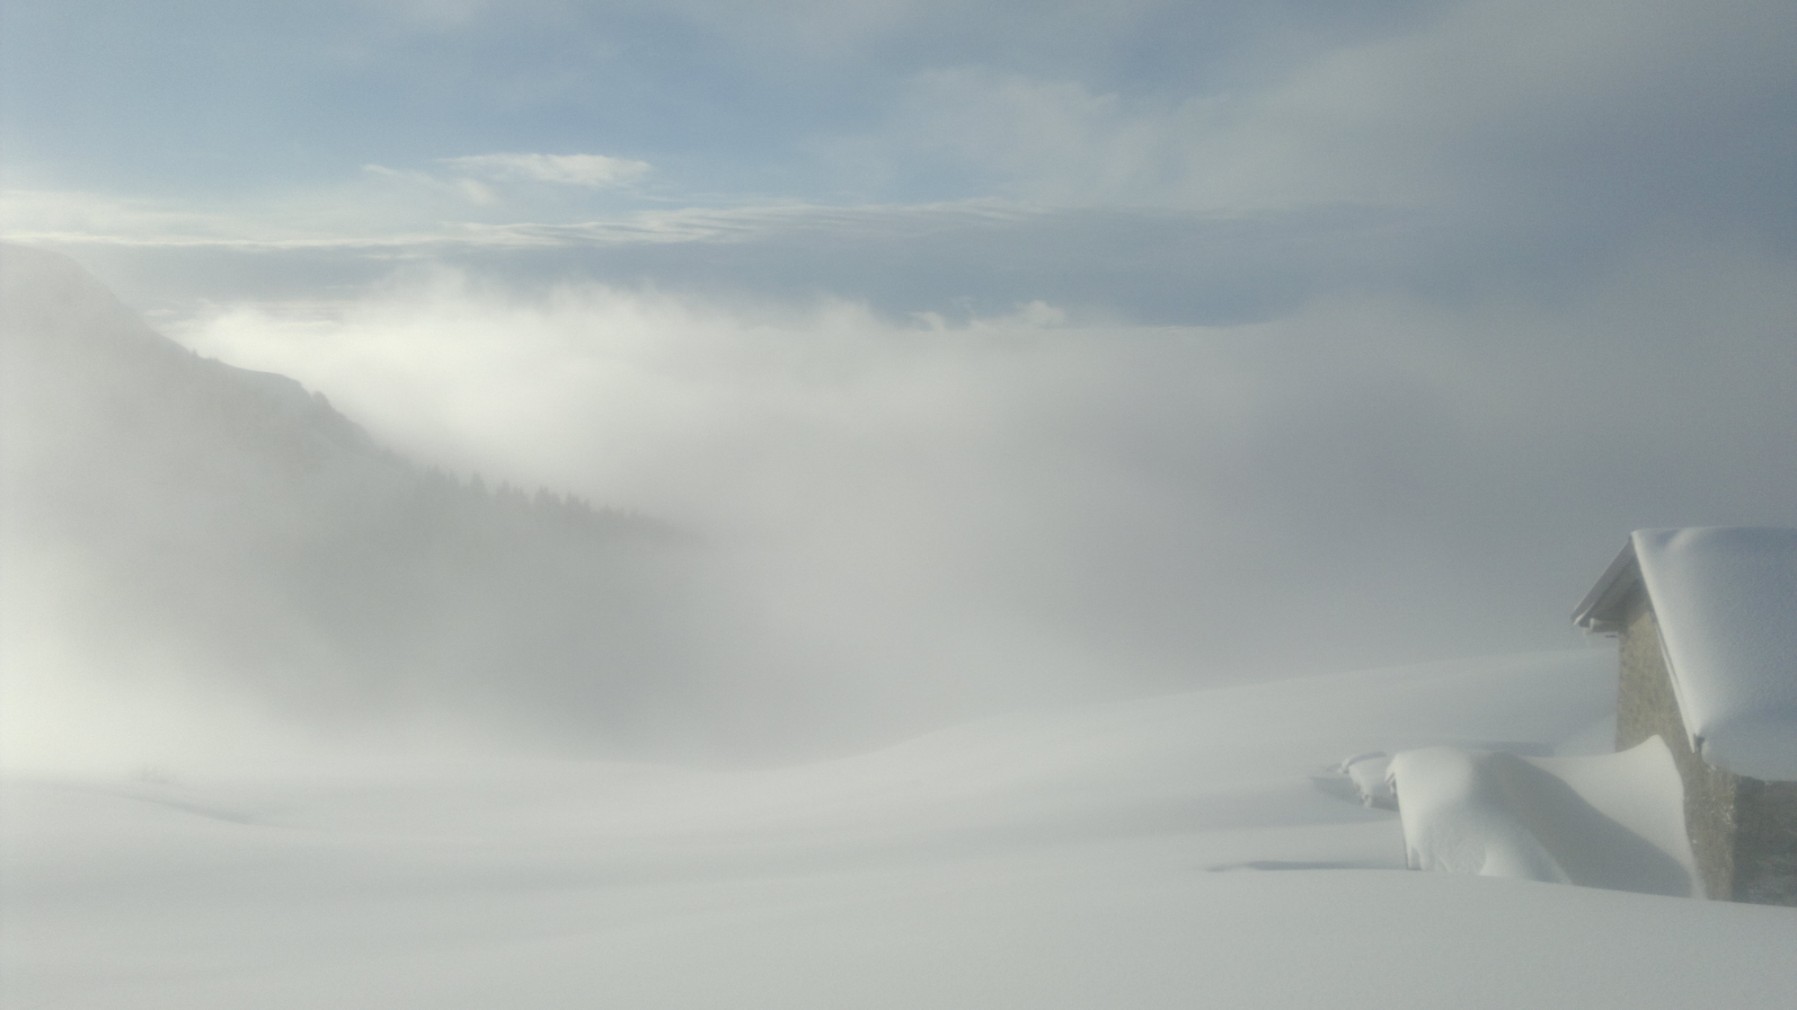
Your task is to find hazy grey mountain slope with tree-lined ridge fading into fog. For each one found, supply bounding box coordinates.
[0,246,722,749]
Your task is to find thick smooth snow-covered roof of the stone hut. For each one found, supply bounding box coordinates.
[1574,527,1797,782]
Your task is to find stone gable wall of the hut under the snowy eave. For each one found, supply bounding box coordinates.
[1616,593,1757,899]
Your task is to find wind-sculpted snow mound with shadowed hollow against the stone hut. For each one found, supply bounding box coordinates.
[1389,737,1702,897]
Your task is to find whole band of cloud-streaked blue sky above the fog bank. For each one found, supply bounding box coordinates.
[0,0,1797,307]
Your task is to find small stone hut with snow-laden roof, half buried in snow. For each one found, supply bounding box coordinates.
[1572,527,1797,906]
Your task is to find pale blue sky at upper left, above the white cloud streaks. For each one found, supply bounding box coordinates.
[7,0,1405,192]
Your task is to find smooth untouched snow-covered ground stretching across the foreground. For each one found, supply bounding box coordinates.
[0,649,1797,1010]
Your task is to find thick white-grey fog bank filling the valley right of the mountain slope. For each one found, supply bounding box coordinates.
[180,240,1797,668]
